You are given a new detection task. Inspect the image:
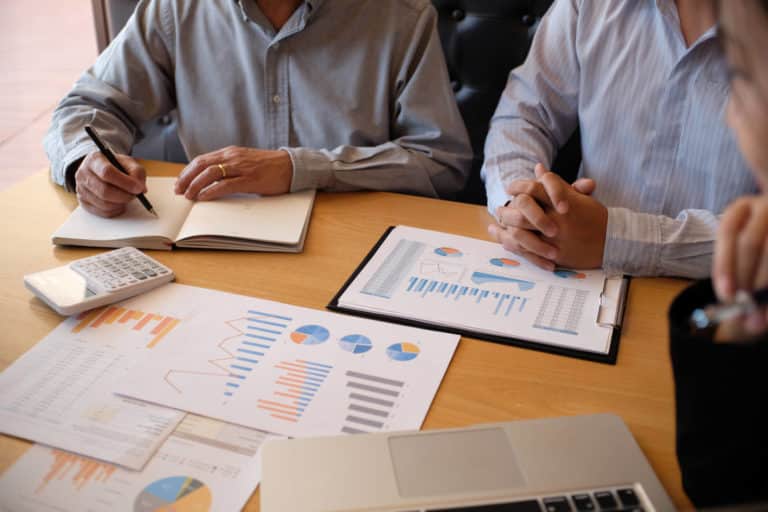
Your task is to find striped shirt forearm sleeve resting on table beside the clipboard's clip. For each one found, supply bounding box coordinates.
[603,208,720,279]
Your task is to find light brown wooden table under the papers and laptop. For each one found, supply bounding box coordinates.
[0,162,690,511]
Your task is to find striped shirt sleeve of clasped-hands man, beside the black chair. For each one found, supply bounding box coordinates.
[482,0,580,214]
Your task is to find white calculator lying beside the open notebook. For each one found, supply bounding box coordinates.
[24,247,174,315]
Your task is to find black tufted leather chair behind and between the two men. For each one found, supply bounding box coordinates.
[432,0,581,204]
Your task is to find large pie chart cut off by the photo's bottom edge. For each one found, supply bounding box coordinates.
[133,476,213,512]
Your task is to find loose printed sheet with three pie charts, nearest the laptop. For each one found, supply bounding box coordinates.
[113,284,459,437]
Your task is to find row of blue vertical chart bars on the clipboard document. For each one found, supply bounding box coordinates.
[405,276,528,316]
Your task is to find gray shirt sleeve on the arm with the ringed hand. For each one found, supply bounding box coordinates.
[282,6,472,198]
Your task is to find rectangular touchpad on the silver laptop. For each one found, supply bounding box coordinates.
[389,428,525,498]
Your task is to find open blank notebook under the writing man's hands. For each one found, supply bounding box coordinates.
[53,178,315,252]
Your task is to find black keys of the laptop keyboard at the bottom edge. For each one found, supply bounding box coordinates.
[409,487,646,512]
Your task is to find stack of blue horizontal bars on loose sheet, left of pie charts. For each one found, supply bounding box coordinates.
[224,309,292,397]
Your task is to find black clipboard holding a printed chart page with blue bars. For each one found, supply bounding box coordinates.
[328,226,629,364]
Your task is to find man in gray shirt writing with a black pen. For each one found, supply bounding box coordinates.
[45,0,471,216]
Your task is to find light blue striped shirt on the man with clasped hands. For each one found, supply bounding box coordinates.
[483,0,757,278]
